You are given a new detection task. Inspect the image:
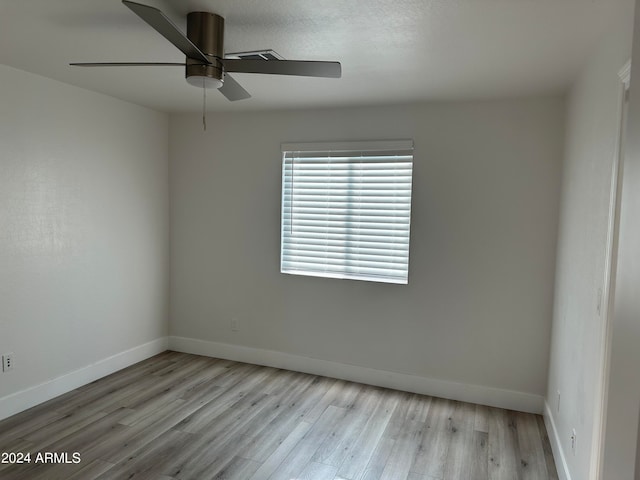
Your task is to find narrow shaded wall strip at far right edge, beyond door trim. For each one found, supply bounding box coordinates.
[602,1,640,480]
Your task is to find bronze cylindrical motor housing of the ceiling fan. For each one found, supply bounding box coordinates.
[185,12,224,88]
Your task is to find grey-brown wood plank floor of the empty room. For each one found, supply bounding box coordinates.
[0,352,558,480]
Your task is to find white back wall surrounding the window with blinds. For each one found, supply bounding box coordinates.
[170,98,564,409]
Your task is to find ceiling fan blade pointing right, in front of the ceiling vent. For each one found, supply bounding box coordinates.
[222,58,342,78]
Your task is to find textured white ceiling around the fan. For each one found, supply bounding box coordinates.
[0,0,633,112]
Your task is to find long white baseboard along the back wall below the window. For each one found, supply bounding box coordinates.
[169,337,544,414]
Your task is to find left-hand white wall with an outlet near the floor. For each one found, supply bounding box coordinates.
[0,66,168,418]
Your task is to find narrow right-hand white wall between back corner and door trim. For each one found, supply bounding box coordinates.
[547,2,633,480]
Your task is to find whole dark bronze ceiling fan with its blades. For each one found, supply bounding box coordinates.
[70,0,342,101]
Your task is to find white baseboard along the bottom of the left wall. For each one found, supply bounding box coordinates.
[0,337,168,420]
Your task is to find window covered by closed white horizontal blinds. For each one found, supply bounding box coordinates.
[280,140,413,284]
